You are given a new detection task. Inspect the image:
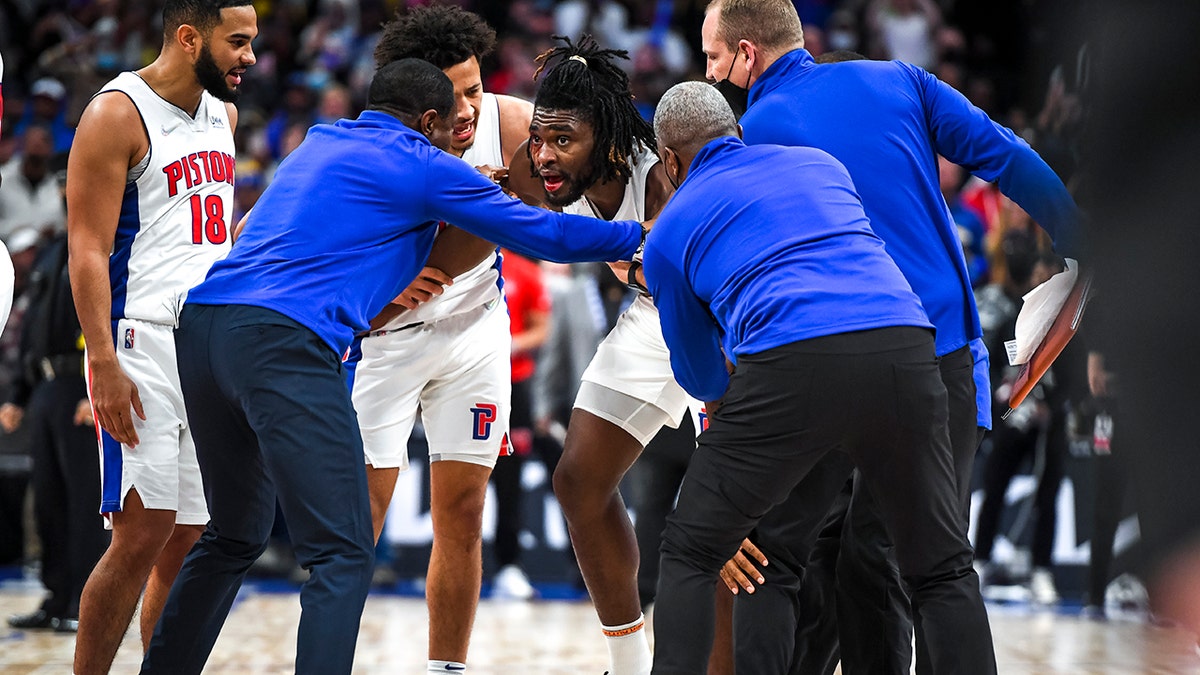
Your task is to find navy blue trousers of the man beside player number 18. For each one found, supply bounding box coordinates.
[142,305,374,675]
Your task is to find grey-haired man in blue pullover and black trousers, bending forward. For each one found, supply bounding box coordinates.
[643,83,996,675]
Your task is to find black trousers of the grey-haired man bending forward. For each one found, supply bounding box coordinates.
[654,328,996,675]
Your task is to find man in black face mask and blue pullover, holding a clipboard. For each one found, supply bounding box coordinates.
[702,0,1080,673]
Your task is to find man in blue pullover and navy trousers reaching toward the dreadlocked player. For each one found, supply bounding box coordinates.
[142,59,643,675]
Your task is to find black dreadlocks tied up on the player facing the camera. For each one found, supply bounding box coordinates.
[530,35,656,180]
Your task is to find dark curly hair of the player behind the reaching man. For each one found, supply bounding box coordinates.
[374,5,496,70]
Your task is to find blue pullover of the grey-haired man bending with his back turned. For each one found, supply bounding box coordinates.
[643,137,931,401]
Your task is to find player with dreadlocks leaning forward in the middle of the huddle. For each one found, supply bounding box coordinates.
[509,36,700,675]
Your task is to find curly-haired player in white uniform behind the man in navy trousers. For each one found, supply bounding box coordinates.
[347,5,533,673]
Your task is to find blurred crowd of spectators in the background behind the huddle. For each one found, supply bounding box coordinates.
[0,0,1123,603]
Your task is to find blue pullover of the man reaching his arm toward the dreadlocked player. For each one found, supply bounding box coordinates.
[187,110,642,353]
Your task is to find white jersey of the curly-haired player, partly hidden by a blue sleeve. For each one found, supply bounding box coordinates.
[382,94,505,330]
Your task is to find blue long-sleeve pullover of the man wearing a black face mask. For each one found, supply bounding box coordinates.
[740,49,1081,426]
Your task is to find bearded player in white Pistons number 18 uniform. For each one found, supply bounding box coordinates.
[67,0,258,675]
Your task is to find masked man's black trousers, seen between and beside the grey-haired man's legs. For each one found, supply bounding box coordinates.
[734,347,983,675]
